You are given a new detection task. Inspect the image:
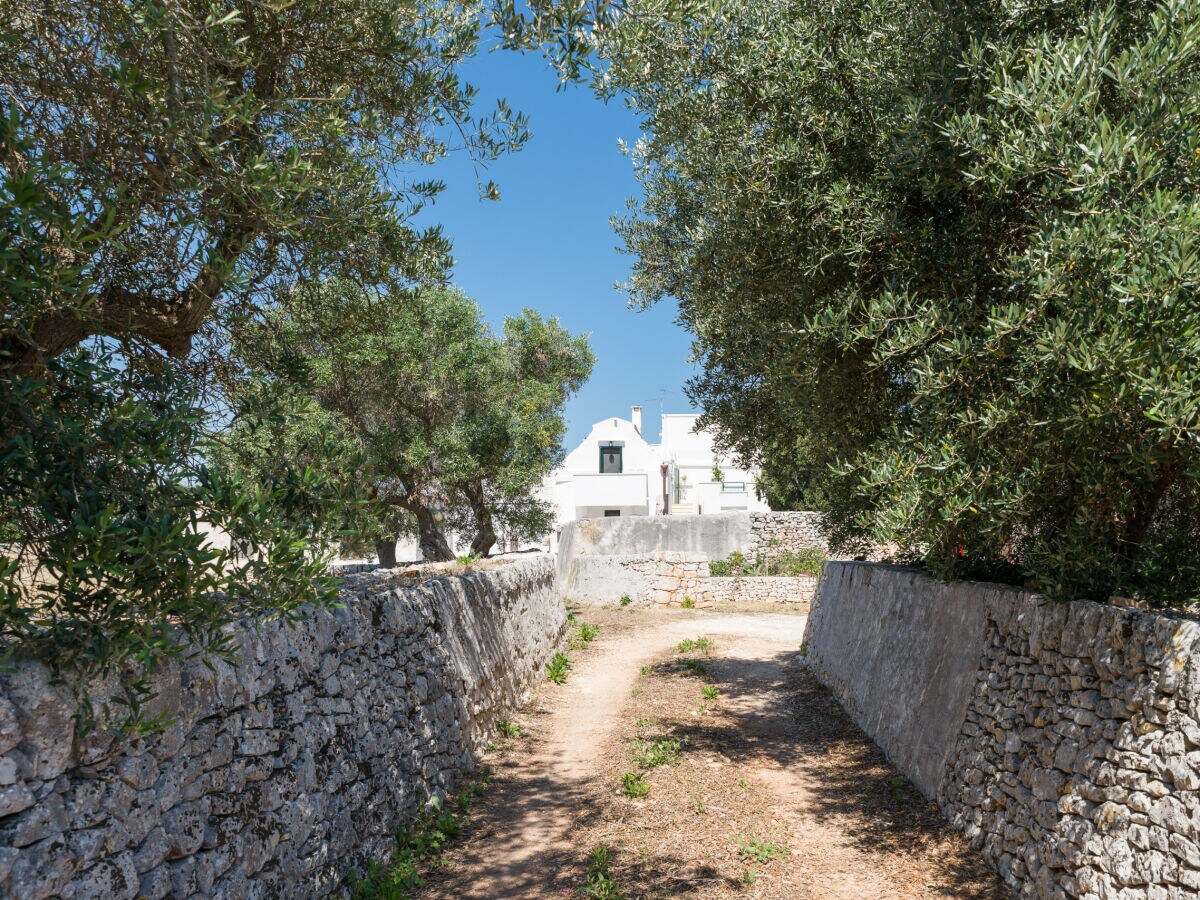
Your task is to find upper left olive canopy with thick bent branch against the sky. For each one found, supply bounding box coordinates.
[0,0,528,360]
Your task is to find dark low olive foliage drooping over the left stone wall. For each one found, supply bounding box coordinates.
[0,344,336,732]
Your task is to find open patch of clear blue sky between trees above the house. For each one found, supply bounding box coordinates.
[422,47,694,449]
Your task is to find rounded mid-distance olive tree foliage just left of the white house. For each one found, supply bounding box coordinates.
[224,282,592,560]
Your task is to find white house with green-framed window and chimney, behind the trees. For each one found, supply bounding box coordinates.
[546,407,769,526]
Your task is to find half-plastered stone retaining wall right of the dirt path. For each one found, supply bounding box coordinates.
[805,563,1200,900]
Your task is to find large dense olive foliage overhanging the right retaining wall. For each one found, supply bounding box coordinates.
[590,0,1200,602]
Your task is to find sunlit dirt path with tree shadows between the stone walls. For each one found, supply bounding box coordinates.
[422,610,998,900]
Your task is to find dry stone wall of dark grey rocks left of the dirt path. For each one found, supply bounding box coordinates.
[0,557,566,900]
